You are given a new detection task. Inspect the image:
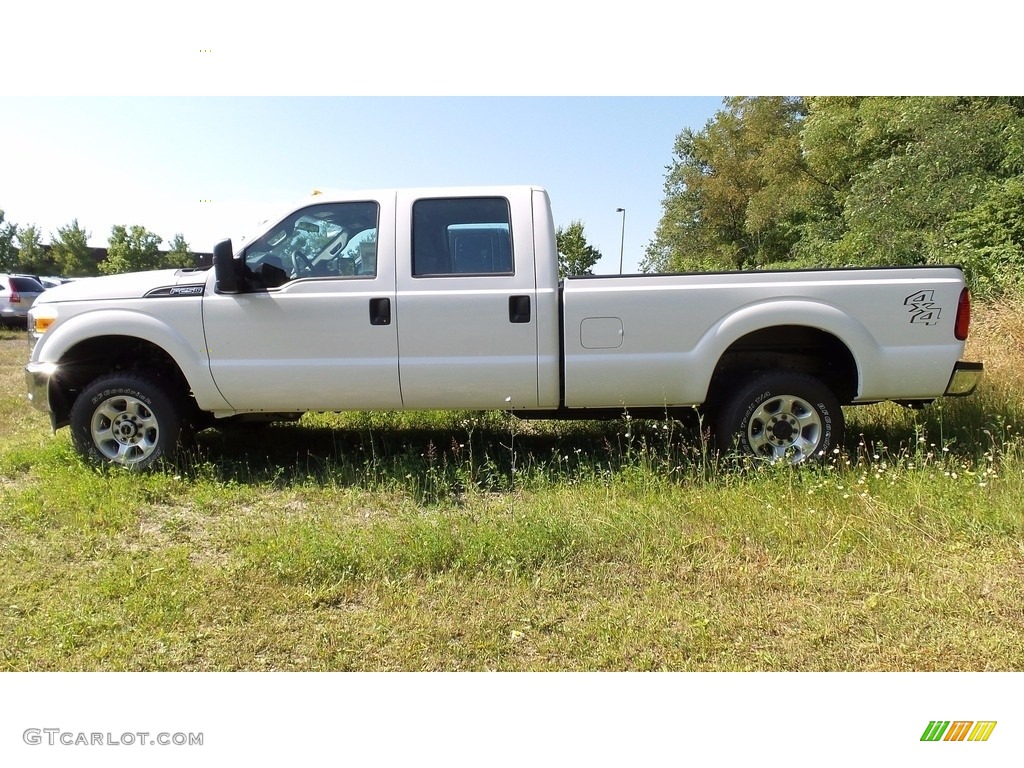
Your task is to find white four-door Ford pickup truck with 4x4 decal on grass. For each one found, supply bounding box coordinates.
[26,186,982,468]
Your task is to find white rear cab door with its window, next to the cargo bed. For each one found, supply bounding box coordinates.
[396,191,538,409]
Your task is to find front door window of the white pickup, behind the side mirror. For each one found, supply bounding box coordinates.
[245,202,379,288]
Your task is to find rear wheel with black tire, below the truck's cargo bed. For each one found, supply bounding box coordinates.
[715,371,844,464]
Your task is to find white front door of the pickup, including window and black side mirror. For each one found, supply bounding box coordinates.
[203,199,401,412]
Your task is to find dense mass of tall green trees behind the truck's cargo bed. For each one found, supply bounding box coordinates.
[642,96,1024,295]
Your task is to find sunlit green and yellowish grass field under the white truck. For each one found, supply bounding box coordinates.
[0,301,1024,671]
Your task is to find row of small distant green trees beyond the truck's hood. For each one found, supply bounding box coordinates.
[0,210,196,278]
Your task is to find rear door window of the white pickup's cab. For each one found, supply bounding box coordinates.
[413,198,515,278]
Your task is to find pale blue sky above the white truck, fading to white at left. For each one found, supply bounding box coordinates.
[0,96,721,272]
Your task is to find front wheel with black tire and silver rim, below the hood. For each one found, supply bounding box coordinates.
[71,374,187,470]
